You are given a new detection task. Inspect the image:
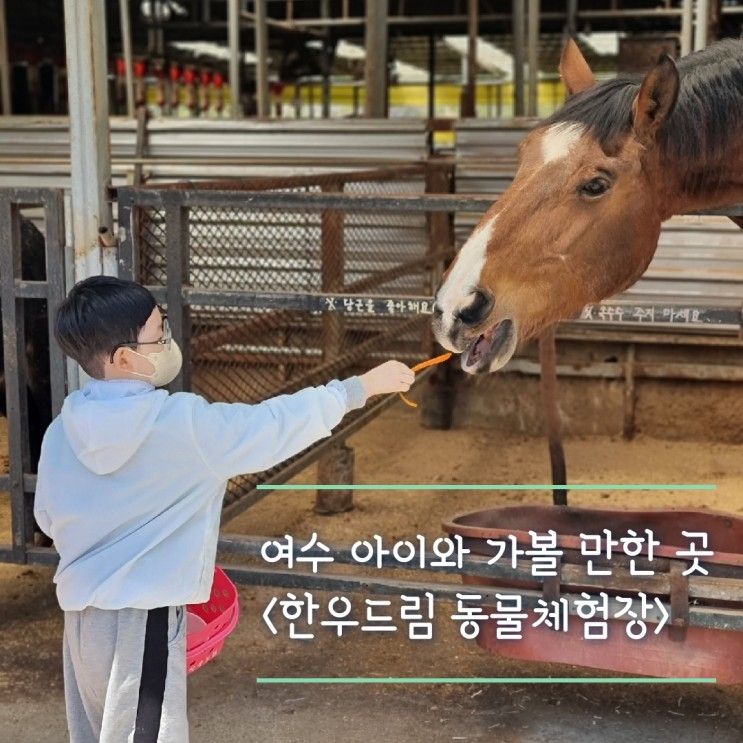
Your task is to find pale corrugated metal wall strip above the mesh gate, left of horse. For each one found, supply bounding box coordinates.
[0,116,427,188]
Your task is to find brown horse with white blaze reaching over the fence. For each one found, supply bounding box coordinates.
[433,40,743,373]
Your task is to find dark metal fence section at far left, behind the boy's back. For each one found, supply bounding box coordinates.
[0,189,66,563]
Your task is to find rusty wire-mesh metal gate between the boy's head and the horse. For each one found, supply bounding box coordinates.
[118,165,453,518]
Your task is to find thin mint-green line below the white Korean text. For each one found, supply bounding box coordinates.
[256,676,717,684]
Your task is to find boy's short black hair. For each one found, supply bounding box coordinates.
[54,276,156,379]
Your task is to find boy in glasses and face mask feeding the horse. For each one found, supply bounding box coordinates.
[34,276,414,743]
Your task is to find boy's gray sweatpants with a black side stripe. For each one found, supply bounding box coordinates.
[63,606,188,743]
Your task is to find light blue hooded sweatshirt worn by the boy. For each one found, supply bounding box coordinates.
[34,377,366,611]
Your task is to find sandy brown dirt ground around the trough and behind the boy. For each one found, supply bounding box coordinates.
[0,406,743,743]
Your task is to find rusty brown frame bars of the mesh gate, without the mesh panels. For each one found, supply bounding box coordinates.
[117,162,454,521]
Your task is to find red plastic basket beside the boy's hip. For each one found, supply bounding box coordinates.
[186,567,240,673]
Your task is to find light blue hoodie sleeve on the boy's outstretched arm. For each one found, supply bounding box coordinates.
[193,377,366,480]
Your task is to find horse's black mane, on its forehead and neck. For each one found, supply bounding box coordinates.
[545,39,743,162]
